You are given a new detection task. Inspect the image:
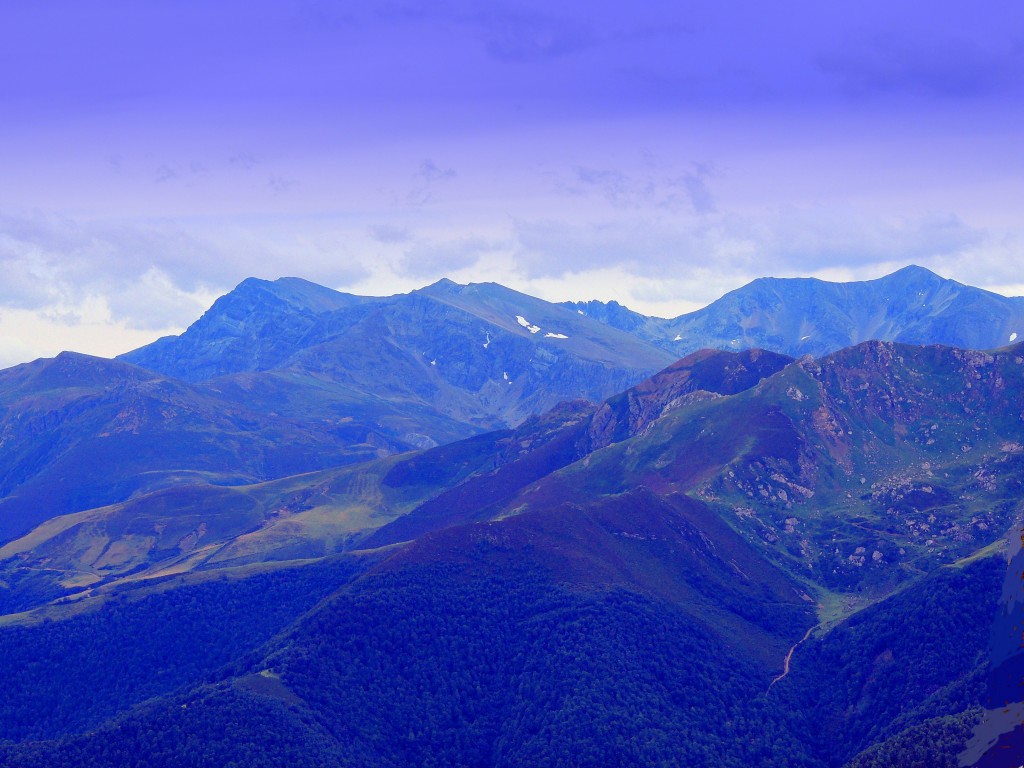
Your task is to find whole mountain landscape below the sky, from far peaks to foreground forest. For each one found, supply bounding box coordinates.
[0,266,1024,768]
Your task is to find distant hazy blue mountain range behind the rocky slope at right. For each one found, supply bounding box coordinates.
[564,266,1024,356]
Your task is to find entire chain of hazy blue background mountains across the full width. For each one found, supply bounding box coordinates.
[0,267,1024,543]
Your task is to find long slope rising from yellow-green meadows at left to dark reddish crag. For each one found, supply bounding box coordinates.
[0,351,790,610]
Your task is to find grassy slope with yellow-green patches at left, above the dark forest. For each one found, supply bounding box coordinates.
[0,423,528,612]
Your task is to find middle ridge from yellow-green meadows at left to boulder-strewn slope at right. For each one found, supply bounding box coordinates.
[0,342,1024,609]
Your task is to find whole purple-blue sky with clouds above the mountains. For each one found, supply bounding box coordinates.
[0,0,1024,366]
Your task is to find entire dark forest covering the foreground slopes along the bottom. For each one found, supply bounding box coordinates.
[0,558,1005,768]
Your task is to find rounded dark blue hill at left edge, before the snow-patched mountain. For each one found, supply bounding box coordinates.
[0,352,395,542]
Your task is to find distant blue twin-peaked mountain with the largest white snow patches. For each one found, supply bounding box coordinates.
[120,279,674,434]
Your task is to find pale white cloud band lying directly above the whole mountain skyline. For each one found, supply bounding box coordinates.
[0,192,1024,366]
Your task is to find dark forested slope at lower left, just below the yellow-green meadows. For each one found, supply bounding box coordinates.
[0,559,357,741]
